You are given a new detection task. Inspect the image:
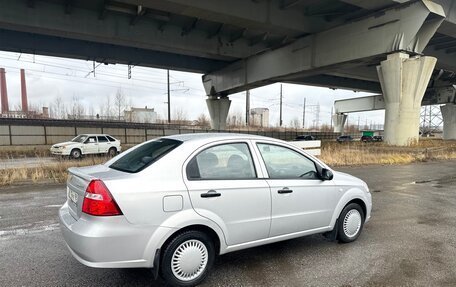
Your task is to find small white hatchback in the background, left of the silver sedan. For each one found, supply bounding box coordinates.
[50,134,121,158]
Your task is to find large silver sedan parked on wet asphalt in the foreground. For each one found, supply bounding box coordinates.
[59,134,372,286]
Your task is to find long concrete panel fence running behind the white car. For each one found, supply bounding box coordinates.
[0,119,339,146]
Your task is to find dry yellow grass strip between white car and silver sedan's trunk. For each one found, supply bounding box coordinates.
[0,157,108,186]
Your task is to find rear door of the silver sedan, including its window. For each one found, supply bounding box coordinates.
[184,141,271,248]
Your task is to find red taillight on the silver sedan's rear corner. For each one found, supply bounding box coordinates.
[82,179,122,216]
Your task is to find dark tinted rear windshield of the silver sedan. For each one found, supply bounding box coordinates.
[109,139,182,173]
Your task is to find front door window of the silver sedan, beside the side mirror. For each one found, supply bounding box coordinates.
[257,143,318,179]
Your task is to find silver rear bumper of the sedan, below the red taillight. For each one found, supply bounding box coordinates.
[59,203,169,268]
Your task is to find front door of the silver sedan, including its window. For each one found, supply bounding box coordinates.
[257,143,338,237]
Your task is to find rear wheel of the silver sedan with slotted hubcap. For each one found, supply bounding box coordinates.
[161,230,215,286]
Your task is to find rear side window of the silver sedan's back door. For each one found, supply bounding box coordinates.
[187,143,256,180]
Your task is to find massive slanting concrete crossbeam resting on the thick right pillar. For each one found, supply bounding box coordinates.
[203,0,445,97]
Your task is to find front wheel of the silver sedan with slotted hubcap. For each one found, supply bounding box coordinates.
[337,203,365,243]
